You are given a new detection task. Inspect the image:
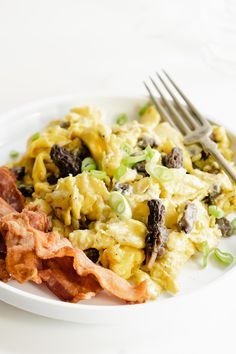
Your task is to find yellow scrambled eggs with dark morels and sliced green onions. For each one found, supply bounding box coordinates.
[9,104,236,299]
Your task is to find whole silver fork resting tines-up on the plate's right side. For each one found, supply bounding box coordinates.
[144,70,236,182]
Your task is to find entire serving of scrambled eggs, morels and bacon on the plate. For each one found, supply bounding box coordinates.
[0,105,236,303]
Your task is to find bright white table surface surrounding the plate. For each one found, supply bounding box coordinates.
[0,0,236,354]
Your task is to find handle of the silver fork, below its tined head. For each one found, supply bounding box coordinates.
[199,136,236,182]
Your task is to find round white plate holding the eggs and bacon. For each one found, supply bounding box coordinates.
[0,95,236,323]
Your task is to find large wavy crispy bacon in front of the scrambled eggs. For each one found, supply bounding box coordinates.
[0,210,148,303]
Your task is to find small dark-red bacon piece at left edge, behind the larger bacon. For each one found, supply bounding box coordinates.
[0,166,25,211]
